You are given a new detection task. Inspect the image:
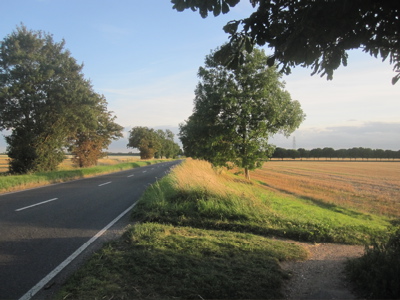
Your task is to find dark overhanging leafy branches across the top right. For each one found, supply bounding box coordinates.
[171,0,400,84]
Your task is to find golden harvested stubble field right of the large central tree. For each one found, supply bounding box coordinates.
[251,161,400,217]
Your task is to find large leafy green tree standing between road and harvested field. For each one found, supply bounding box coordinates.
[179,49,305,179]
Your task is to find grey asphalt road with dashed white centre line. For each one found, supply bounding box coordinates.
[0,161,180,299]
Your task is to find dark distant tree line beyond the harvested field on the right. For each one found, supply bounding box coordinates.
[272,147,400,160]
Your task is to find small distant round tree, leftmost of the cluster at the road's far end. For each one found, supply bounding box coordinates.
[127,126,162,159]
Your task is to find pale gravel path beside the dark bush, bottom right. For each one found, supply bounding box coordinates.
[282,242,364,299]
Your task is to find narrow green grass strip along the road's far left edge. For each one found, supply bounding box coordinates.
[0,160,165,193]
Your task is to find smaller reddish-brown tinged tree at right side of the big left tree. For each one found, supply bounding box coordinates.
[69,93,123,168]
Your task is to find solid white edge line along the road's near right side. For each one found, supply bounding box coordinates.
[19,202,138,300]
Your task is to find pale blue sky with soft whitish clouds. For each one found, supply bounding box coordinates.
[0,0,400,152]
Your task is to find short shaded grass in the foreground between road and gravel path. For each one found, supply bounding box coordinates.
[57,223,306,299]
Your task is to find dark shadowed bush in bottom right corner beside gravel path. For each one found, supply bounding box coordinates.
[346,228,400,299]
